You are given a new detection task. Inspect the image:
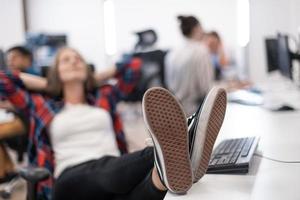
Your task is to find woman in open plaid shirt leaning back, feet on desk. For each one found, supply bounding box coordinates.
[0,48,226,200]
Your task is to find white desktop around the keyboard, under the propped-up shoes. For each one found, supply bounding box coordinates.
[165,104,300,200]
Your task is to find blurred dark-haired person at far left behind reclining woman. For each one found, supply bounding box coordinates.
[6,46,39,75]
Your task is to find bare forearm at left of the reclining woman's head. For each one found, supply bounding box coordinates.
[20,73,47,91]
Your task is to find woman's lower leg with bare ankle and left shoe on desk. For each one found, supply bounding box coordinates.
[114,88,192,200]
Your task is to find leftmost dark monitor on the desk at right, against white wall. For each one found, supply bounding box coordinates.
[265,38,279,72]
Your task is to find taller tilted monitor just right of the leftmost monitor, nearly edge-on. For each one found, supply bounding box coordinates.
[277,34,292,78]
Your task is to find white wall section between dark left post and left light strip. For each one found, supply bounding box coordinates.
[27,0,105,68]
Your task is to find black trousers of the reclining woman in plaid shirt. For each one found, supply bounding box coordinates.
[54,147,166,200]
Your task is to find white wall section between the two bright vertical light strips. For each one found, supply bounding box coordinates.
[114,0,237,52]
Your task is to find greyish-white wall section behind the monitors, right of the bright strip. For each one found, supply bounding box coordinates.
[249,0,300,81]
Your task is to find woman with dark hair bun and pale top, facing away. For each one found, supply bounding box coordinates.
[165,16,214,115]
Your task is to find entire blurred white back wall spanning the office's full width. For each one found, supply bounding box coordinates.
[0,0,300,81]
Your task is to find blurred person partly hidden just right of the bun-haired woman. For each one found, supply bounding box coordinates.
[204,31,230,80]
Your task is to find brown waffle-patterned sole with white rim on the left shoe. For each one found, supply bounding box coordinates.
[142,87,193,194]
